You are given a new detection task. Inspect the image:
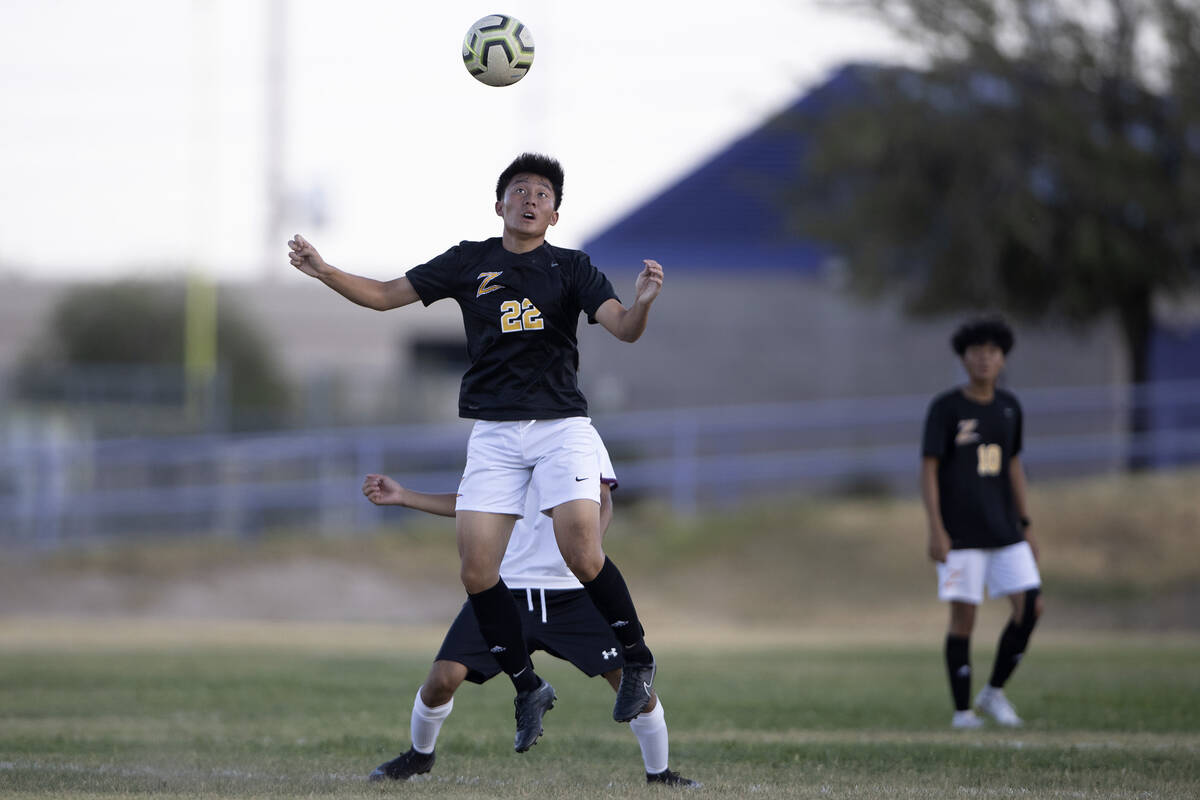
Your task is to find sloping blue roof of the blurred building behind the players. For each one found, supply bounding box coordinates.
[583,66,862,273]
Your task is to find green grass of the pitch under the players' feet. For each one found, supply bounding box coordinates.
[0,624,1200,799]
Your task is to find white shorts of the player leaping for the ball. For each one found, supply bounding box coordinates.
[455,416,600,517]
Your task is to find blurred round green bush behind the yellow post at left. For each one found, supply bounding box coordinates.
[18,281,290,428]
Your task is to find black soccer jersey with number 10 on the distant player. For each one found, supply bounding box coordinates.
[922,389,1025,549]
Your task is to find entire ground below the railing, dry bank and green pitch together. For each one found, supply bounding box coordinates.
[0,470,1200,800]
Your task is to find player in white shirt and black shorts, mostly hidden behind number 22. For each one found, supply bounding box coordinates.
[362,437,700,787]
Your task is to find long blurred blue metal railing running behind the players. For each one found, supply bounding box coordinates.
[0,381,1200,548]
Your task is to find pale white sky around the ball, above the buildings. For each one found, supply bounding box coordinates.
[0,0,906,281]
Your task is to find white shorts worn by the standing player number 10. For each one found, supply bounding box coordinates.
[937,542,1042,606]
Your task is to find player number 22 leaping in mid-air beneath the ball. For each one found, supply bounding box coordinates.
[288,154,662,752]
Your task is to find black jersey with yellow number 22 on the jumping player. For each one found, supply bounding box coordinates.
[408,239,618,420]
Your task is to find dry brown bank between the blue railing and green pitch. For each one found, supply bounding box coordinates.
[0,470,1200,637]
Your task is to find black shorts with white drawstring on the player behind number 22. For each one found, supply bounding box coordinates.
[438,589,625,684]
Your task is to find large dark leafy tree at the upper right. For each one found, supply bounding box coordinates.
[780,0,1200,388]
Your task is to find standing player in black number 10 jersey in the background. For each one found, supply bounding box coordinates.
[920,319,1042,728]
